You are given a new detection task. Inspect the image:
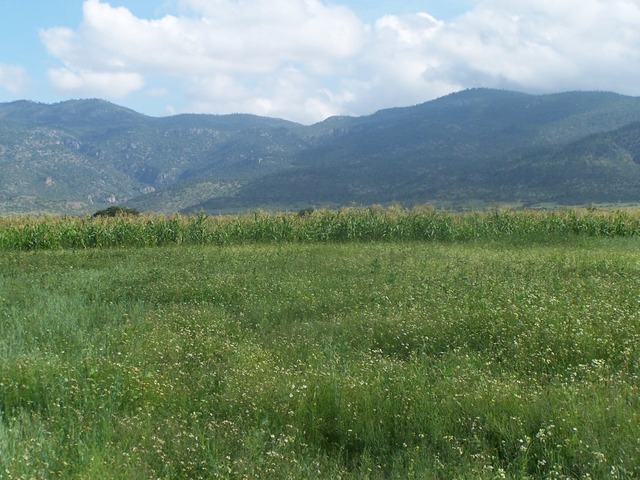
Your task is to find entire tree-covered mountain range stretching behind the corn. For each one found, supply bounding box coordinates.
[0,89,640,214]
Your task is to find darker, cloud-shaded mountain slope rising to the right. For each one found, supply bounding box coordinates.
[198,90,640,210]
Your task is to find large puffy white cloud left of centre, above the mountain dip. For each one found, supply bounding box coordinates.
[41,0,367,121]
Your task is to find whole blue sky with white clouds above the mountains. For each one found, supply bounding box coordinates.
[0,0,640,124]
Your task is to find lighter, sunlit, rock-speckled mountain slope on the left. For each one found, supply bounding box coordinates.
[0,100,298,212]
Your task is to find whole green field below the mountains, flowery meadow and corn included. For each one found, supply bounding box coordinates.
[0,208,640,480]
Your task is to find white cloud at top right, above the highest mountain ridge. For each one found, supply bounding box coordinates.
[427,0,640,94]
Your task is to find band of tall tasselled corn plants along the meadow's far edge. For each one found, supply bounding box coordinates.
[0,207,640,250]
